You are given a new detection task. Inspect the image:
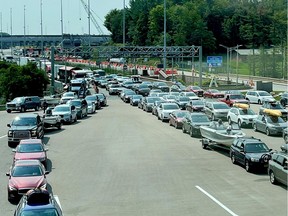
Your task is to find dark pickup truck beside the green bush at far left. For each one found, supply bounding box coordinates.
[6,96,41,113]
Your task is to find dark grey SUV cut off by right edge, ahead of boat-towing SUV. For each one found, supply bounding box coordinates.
[268,144,288,186]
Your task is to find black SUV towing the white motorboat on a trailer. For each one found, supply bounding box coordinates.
[230,137,272,172]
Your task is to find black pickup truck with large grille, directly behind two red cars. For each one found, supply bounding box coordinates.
[7,113,44,147]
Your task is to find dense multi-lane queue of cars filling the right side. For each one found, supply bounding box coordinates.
[100,76,288,185]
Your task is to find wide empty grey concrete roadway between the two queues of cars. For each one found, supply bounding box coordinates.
[0,93,287,216]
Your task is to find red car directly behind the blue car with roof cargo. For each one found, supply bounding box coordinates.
[6,160,49,201]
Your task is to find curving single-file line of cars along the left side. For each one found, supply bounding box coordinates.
[6,88,107,216]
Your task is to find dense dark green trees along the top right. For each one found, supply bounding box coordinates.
[104,0,287,78]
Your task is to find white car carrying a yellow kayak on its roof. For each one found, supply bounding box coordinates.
[227,104,258,128]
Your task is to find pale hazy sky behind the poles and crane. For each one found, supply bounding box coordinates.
[0,0,124,35]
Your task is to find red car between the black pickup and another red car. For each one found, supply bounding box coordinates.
[13,139,48,167]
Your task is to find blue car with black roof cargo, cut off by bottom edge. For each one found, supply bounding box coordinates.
[14,189,63,216]
